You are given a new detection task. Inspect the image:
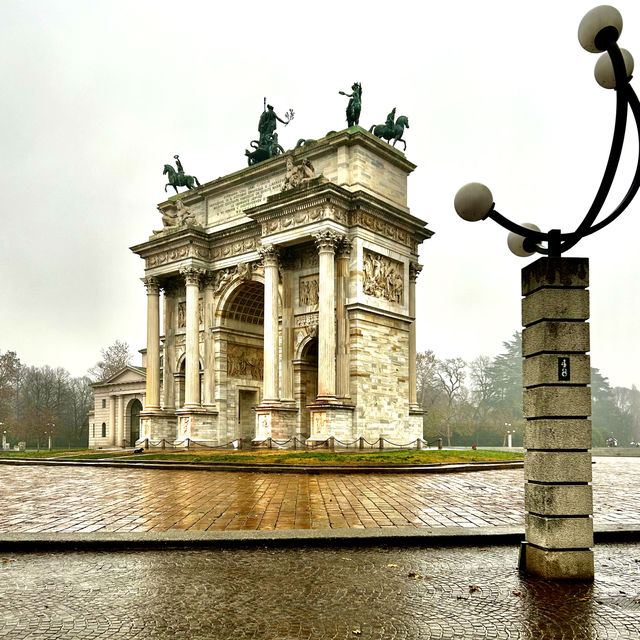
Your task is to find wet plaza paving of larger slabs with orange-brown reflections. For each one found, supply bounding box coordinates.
[0,458,640,533]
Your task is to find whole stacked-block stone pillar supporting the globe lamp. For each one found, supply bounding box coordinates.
[520,258,594,580]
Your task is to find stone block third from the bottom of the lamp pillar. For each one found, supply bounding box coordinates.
[524,482,593,516]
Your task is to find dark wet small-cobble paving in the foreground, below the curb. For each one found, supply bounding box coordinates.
[0,544,640,640]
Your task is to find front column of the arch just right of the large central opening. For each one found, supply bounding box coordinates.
[260,245,279,403]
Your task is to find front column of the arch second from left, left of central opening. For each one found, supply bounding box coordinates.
[180,267,204,409]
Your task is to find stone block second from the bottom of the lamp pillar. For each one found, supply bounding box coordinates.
[525,513,593,549]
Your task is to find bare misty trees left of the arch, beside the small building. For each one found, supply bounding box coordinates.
[0,341,131,448]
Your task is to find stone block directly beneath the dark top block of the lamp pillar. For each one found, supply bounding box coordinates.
[522,289,589,327]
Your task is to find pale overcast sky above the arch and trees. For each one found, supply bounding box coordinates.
[0,0,640,386]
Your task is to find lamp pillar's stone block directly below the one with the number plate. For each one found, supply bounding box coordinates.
[522,386,591,418]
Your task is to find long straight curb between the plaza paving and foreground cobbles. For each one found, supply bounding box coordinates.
[0,524,640,552]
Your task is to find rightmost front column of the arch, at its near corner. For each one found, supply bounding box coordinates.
[314,230,339,401]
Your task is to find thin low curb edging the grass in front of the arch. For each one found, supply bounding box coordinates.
[0,458,524,474]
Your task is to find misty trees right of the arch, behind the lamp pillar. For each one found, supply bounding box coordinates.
[416,332,640,446]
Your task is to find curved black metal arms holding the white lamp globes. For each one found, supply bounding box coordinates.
[485,42,640,256]
